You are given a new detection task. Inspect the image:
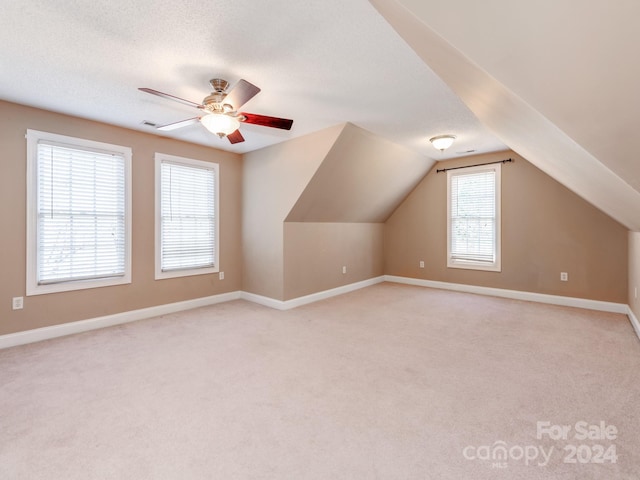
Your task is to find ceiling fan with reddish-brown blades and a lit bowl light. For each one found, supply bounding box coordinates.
[138,78,293,143]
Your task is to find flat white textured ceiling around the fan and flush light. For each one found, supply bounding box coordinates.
[0,0,506,160]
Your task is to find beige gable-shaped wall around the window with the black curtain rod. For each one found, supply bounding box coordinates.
[385,152,628,303]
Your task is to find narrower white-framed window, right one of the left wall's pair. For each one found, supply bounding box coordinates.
[156,153,219,279]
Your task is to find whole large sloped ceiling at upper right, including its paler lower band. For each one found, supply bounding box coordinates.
[370,0,640,231]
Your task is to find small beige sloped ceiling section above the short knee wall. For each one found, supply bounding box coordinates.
[286,123,435,223]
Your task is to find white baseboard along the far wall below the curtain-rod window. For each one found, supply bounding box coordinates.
[385,275,629,313]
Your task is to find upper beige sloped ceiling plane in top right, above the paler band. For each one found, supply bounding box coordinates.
[390,0,640,191]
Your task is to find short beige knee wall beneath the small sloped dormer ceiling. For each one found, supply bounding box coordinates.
[284,222,384,300]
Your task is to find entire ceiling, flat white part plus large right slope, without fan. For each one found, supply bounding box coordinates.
[0,0,640,230]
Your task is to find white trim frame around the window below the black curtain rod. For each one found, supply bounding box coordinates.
[447,163,502,272]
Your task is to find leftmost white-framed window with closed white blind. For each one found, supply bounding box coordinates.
[27,130,131,295]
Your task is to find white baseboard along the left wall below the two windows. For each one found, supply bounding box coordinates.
[0,292,240,349]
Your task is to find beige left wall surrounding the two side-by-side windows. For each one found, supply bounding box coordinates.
[0,102,242,334]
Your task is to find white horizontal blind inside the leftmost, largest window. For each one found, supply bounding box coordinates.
[36,140,127,285]
